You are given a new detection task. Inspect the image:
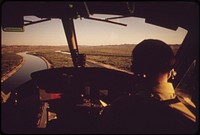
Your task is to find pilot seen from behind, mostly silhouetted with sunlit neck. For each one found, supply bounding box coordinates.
[103,39,197,134]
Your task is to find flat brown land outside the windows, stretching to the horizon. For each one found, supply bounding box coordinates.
[1,44,179,77]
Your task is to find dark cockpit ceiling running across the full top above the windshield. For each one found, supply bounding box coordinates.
[2,1,199,30]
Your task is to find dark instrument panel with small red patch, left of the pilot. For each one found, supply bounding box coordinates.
[4,67,134,133]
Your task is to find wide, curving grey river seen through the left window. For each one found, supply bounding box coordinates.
[1,52,47,93]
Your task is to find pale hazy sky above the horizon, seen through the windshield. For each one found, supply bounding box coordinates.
[1,15,187,45]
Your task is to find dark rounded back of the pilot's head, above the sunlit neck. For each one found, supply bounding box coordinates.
[132,39,175,74]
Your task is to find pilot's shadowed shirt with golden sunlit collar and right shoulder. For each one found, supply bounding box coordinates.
[103,83,197,134]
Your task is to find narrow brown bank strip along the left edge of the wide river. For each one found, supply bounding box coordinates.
[1,57,25,83]
